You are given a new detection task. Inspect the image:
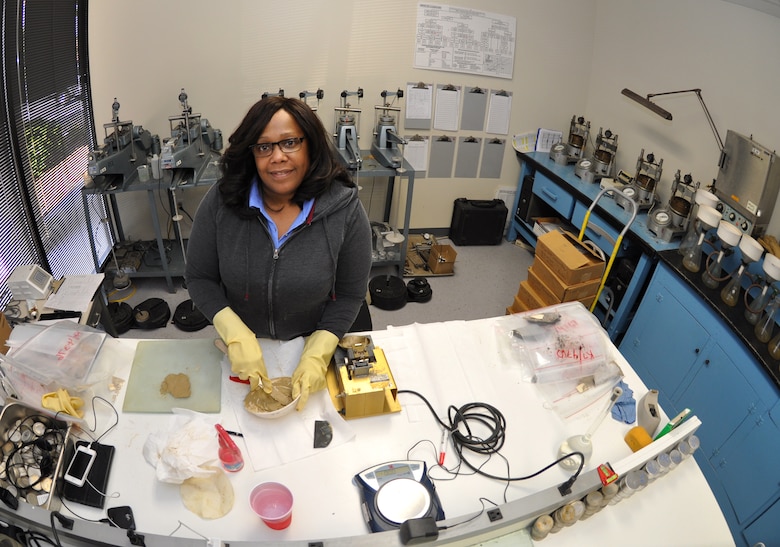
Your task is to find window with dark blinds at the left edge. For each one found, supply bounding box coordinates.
[0,0,110,305]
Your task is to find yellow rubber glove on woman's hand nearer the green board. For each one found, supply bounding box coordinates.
[212,308,272,393]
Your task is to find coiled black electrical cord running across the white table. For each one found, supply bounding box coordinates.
[398,389,585,496]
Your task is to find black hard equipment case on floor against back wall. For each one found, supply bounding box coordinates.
[450,198,507,245]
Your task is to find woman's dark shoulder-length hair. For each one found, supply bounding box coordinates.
[219,97,354,218]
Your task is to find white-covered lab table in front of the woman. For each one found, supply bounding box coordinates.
[4,317,734,547]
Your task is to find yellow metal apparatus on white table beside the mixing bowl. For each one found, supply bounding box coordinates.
[326,335,401,420]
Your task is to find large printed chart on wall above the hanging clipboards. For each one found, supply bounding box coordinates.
[414,2,517,79]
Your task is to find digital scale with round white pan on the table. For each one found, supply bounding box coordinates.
[353,460,444,532]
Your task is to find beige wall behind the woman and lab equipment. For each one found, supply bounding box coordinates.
[89,0,780,238]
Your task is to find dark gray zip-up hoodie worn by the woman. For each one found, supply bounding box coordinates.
[186,181,371,340]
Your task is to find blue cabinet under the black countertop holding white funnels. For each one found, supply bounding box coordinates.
[620,262,780,545]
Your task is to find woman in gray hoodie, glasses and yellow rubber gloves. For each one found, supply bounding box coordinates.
[185,97,371,410]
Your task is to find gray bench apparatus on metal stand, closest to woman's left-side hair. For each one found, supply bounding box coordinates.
[160,88,222,176]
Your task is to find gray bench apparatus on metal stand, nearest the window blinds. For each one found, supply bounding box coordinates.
[87,97,160,189]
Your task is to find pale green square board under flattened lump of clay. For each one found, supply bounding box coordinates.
[122,338,224,412]
